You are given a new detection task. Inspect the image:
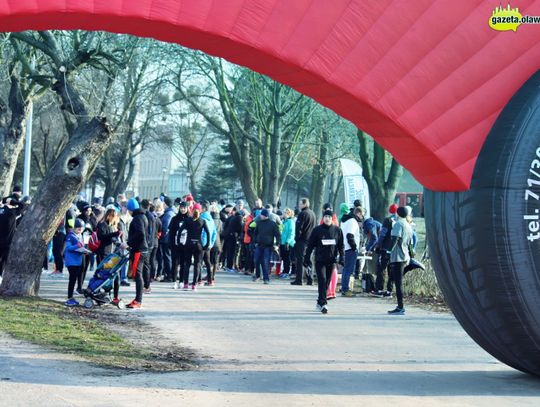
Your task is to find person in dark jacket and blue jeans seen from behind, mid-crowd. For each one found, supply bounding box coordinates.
[253,209,281,284]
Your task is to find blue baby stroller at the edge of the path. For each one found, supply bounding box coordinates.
[84,249,129,309]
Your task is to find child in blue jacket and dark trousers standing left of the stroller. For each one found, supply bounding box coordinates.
[64,218,84,307]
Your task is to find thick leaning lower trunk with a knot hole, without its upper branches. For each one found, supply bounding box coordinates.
[0,118,111,296]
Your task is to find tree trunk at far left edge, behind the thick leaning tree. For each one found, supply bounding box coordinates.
[0,76,28,197]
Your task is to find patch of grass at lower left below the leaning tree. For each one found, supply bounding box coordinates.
[0,297,194,372]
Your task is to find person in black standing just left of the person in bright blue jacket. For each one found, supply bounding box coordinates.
[169,201,193,290]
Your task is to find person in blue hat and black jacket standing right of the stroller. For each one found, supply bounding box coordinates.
[122,198,148,308]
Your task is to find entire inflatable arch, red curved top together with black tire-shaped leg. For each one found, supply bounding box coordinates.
[0,0,540,374]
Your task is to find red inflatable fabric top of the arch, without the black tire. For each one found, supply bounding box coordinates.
[0,0,540,191]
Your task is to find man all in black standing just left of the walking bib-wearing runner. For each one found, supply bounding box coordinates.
[291,198,317,285]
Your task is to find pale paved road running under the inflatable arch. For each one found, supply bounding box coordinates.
[0,273,540,407]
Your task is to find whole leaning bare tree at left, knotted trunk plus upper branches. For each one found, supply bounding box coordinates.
[0,31,133,296]
